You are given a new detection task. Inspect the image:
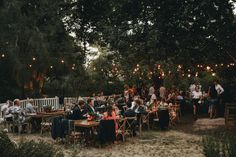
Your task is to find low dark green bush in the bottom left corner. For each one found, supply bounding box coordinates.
[0,133,64,157]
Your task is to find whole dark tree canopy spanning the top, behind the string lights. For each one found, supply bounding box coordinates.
[0,0,236,99]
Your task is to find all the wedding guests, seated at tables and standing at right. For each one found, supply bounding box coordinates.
[1,80,224,134]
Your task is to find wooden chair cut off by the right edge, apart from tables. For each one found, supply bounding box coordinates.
[225,103,236,129]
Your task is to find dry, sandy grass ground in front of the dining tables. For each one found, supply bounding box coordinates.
[4,116,233,157]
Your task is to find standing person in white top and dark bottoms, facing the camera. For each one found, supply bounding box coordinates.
[192,86,202,120]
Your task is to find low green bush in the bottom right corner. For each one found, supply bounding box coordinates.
[202,136,236,157]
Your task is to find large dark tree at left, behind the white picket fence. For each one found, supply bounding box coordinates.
[0,0,83,99]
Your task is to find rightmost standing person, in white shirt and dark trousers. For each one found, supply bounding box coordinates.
[214,80,224,115]
